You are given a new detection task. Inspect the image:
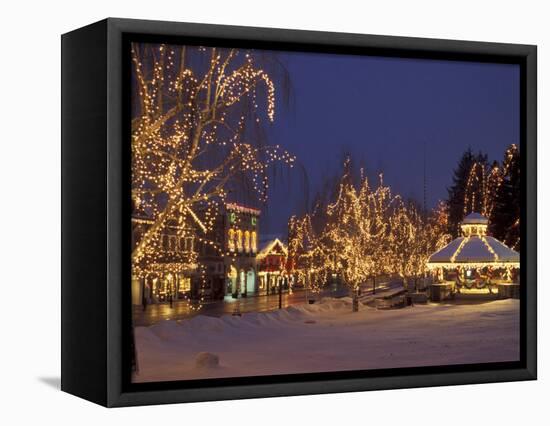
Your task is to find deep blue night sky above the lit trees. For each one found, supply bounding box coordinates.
[256,52,519,234]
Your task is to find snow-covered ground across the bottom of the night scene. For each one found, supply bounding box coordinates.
[134,298,519,382]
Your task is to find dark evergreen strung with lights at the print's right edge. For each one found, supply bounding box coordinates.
[490,145,521,250]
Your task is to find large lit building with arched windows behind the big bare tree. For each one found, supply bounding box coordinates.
[132,203,260,305]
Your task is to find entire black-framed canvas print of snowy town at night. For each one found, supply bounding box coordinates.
[62,19,537,406]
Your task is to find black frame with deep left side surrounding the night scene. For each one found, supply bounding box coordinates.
[61,18,537,407]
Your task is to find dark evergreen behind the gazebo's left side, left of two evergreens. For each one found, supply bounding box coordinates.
[447,148,487,238]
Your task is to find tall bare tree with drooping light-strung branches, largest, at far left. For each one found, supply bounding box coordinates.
[131,43,295,286]
